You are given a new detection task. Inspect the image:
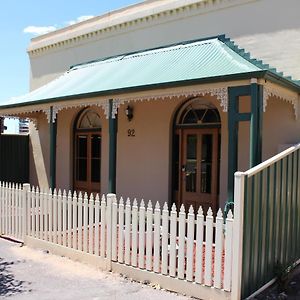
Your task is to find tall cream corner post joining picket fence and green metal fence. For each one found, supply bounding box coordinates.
[231,172,245,300]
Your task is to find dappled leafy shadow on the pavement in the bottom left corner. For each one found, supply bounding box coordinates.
[0,258,30,297]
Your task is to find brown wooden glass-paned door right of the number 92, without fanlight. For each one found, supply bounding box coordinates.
[180,128,219,212]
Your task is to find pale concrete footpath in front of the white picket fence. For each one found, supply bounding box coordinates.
[0,238,190,300]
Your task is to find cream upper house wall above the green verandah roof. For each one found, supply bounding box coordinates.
[29,0,300,89]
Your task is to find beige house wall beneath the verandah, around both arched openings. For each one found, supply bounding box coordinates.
[30,96,300,207]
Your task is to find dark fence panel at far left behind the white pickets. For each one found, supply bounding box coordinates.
[0,134,29,183]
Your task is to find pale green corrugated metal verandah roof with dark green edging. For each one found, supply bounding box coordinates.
[0,36,295,108]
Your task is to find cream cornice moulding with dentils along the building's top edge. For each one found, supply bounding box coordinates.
[27,0,255,56]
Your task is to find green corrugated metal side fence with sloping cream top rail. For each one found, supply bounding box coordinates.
[235,144,300,299]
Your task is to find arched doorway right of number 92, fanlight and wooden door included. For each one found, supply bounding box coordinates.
[173,98,221,212]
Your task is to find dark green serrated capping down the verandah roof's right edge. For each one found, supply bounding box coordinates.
[218,34,300,87]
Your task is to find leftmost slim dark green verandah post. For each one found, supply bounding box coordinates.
[49,106,57,189]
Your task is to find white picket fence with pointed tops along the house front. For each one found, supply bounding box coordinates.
[0,183,233,299]
